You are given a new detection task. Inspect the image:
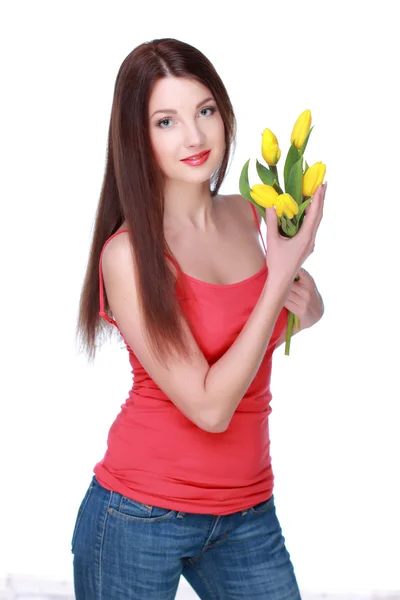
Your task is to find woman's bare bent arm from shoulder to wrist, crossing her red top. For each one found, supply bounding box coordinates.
[102,235,290,433]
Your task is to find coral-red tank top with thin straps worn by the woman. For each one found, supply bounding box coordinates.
[94,203,288,515]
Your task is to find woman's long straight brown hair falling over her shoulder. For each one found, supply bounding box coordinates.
[76,38,236,364]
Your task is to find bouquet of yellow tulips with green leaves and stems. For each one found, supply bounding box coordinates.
[239,110,326,355]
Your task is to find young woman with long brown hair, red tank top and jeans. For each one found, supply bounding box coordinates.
[72,39,325,600]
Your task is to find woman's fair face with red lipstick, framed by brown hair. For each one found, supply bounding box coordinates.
[149,77,225,183]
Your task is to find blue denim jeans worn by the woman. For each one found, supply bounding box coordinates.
[72,477,301,600]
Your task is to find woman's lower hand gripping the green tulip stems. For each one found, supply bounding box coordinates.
[284,268,324,330]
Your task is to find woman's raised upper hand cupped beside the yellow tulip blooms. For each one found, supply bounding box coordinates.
[266,183,327,286]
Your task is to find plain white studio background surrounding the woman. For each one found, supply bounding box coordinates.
[0,0,400,592]
